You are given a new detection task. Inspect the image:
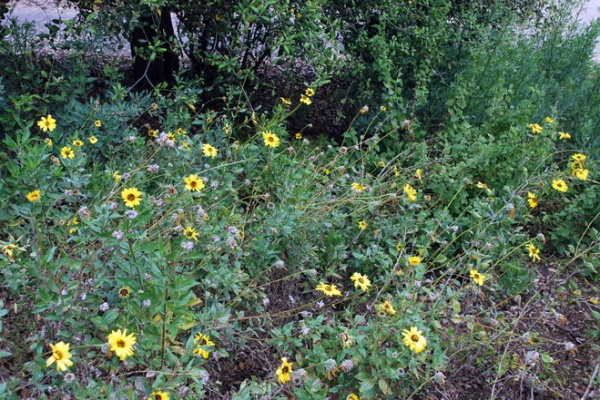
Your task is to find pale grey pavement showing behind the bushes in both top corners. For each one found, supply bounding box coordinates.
[3,0,600,62]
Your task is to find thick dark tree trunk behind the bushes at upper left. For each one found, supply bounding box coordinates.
[129,7,179,89]
